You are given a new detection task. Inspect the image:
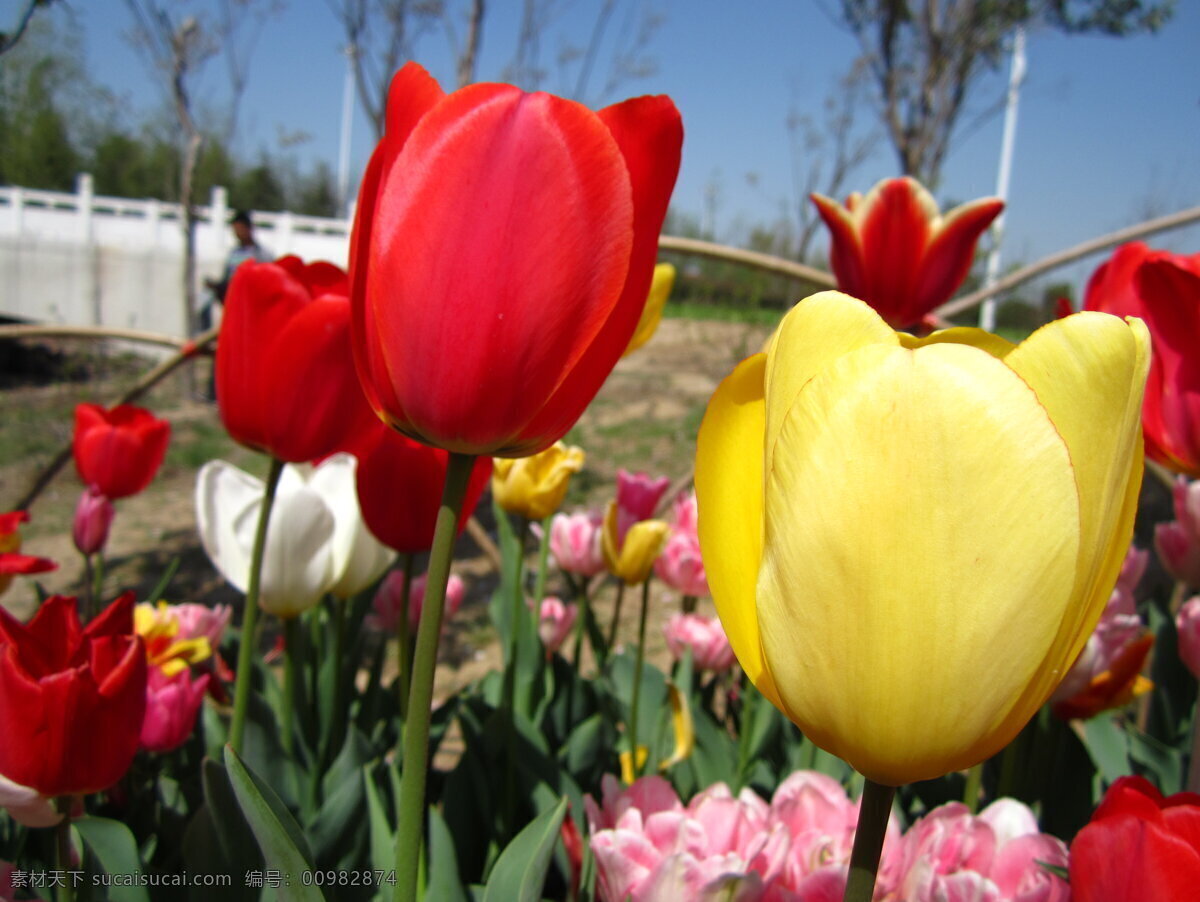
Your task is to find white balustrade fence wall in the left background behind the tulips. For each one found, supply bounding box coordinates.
[0,175,350,336]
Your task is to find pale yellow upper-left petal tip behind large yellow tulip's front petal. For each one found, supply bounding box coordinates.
[764,291,899,479]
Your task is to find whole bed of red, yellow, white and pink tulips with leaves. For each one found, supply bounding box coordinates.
[0,64,1200,902]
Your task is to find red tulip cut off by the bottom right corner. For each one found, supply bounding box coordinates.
[1070,777,1200,902]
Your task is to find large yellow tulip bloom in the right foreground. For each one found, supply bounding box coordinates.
[696,291,1150,786]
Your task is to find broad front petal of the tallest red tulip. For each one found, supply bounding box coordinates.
[369,85,633,452]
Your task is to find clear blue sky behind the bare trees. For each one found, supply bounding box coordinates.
[11,0,1200,301]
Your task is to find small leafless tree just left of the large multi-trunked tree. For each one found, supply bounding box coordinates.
[787,66,883,260]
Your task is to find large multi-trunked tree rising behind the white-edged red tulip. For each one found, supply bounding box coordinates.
[833,0,1174,186]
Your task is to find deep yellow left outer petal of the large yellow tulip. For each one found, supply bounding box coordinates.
[696,354,782,708]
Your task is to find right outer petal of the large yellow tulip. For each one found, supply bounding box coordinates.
[1004,312,1150,704]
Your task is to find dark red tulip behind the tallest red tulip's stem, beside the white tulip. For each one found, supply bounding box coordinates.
[353,423,492,553]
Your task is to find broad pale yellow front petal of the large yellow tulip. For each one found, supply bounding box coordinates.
[757,343,1079,784]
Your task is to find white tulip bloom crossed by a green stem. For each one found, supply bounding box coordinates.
[196,453,392,618]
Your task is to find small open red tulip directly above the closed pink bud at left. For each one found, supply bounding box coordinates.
[72,404,170,500]
